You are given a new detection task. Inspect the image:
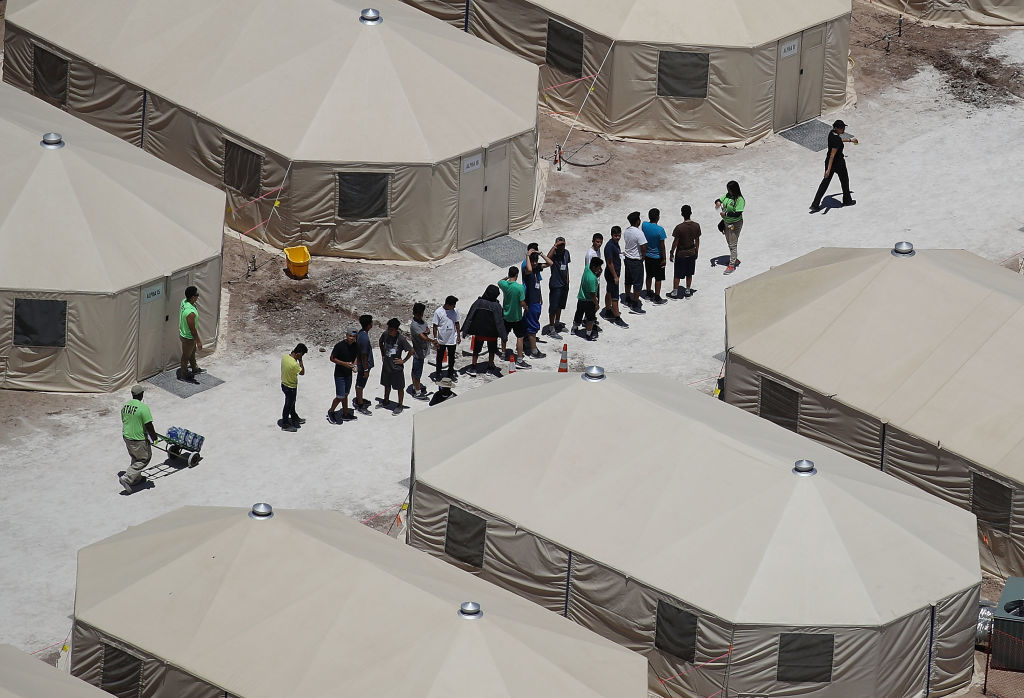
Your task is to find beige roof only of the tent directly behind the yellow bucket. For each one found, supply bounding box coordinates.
[7,0,538,164]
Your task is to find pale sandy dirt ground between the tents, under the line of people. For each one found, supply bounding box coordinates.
[0,0,1024,683]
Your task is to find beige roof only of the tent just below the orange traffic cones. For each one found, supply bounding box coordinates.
[415,374,981,625]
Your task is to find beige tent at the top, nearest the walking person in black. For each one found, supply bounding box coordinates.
[406,0,851,143]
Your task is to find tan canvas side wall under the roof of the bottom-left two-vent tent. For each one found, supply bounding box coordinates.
[71,620,226,698]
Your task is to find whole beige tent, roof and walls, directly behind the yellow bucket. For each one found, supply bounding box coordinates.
[3,0,539,260]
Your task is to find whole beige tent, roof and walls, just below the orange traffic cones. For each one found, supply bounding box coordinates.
[409,373,981,698]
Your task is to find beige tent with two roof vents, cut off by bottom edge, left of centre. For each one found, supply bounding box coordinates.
[72,505,646,698]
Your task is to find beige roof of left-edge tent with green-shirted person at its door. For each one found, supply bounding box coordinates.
[0,85,224,293]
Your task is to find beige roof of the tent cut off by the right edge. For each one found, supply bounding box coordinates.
[726,249,1024,480]
